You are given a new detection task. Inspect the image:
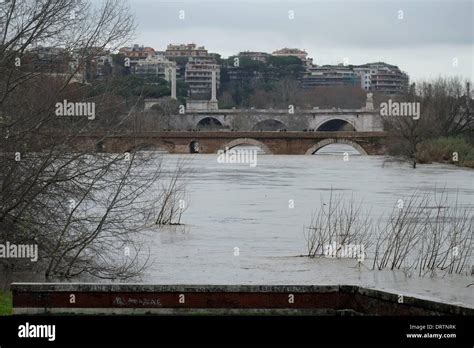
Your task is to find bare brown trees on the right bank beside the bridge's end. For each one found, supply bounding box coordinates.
[383,78,474,168]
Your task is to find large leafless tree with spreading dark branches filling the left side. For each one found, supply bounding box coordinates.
[0,0,187,279]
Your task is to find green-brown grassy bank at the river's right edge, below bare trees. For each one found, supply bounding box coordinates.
[416,136,474,168]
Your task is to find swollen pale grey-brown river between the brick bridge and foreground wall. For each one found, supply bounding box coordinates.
[142,145,474,306]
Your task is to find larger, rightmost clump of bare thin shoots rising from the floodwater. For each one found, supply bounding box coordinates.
[373,190,474,276]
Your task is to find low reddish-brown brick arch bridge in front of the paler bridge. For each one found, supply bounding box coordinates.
[76,131,386,155]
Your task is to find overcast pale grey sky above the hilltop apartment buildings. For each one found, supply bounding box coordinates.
[129,0,474,80]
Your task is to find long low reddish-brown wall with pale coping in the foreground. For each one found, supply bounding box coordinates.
[11,283,474,315]
